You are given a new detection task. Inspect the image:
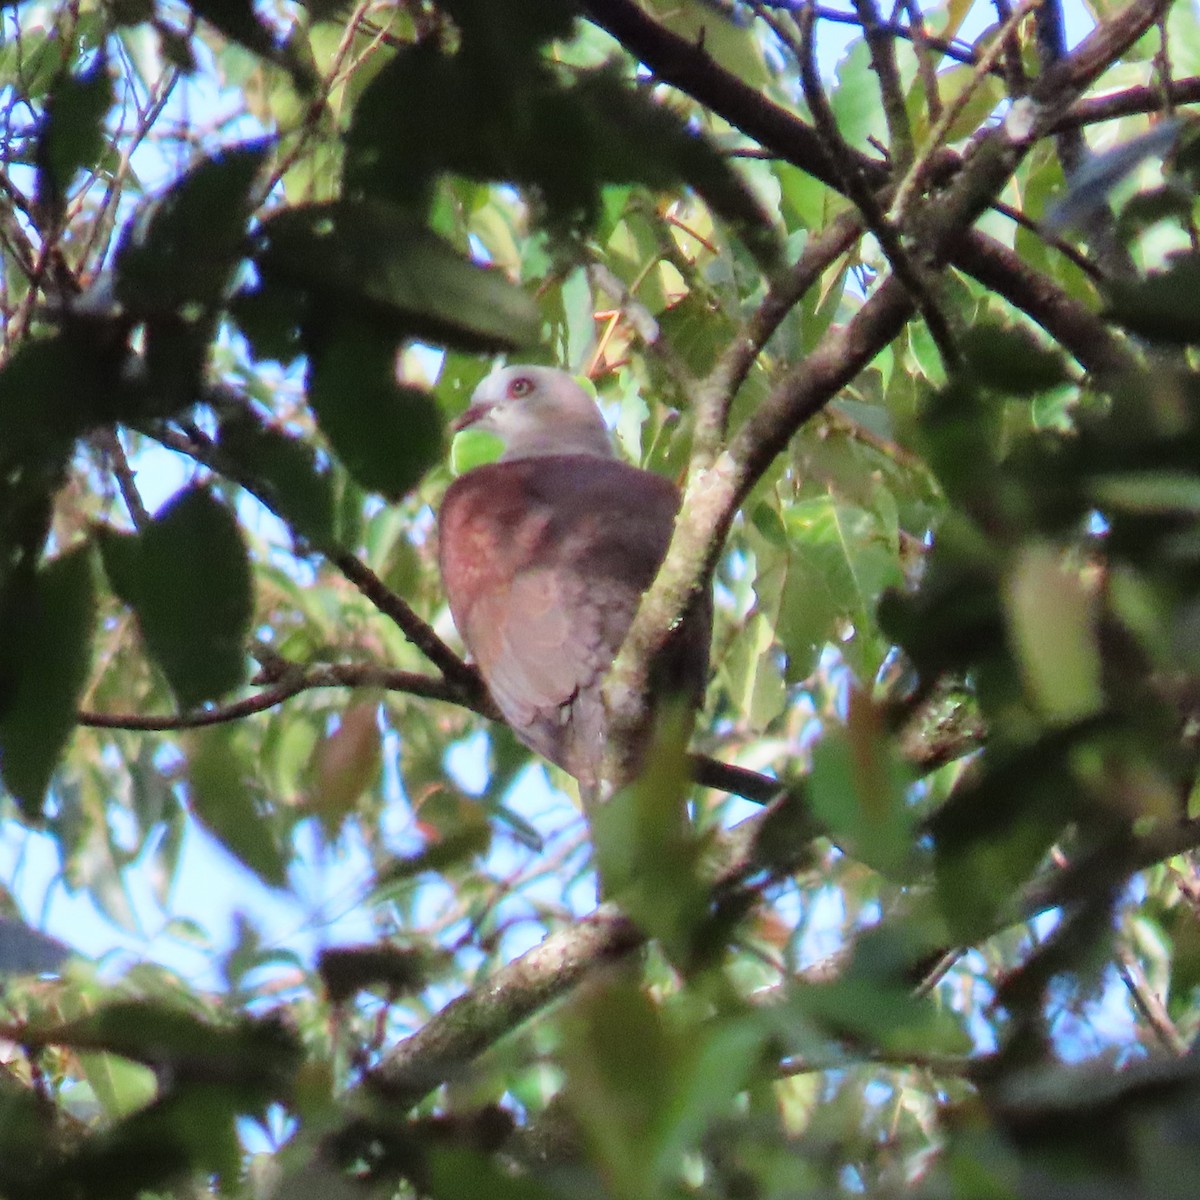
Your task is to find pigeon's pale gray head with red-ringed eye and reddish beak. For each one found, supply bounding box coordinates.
[454,366,613,462]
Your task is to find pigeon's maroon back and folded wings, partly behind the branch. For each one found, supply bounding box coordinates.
[438,455,712,786]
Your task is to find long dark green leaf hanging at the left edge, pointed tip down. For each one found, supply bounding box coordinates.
[0,546,95,817]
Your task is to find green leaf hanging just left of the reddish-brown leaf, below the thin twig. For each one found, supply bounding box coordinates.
[187,726,288,888]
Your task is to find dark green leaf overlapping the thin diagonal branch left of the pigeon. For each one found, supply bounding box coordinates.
[217,410,334,546]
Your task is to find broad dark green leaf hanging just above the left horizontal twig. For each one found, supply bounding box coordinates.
[100,487,253,709]
